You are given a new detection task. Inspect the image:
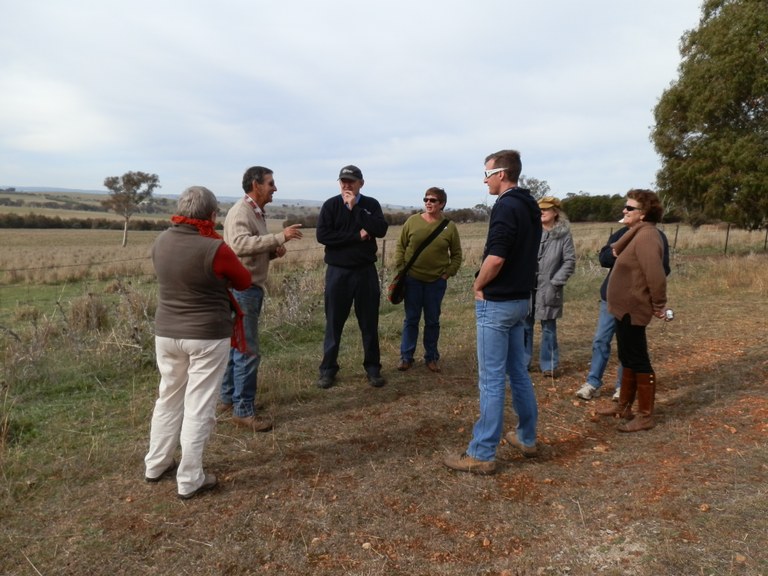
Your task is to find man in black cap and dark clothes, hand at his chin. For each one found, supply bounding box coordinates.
[317,166,389,388]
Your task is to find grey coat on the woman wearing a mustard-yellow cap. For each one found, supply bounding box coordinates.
[534,214,576,320]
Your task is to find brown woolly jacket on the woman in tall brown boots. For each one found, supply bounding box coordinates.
[607,222,667,326]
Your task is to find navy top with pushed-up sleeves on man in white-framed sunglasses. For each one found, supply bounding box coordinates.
[483,187,541,301]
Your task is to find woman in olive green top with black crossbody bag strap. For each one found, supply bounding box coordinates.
[395,187,461,372]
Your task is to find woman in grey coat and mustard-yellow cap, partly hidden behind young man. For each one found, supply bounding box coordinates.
[525,196,576,377]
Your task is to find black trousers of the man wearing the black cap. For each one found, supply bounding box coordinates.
[320,264,381,377]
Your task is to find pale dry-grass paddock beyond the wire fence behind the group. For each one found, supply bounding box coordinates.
[0,220,766,286]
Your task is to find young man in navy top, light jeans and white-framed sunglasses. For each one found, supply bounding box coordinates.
[444,150,541,474]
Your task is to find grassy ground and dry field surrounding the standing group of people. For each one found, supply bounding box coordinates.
[0,222,768,576]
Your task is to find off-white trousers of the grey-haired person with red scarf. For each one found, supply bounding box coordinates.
[144,336,230,494]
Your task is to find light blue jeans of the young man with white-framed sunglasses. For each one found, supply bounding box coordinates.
[467,299,539,461]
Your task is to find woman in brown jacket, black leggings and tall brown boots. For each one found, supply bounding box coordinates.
[598,190,667,432]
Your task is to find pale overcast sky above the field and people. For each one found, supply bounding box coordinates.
[0,0,701,208]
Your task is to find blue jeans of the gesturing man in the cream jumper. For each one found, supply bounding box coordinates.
[220,286,264,418]
